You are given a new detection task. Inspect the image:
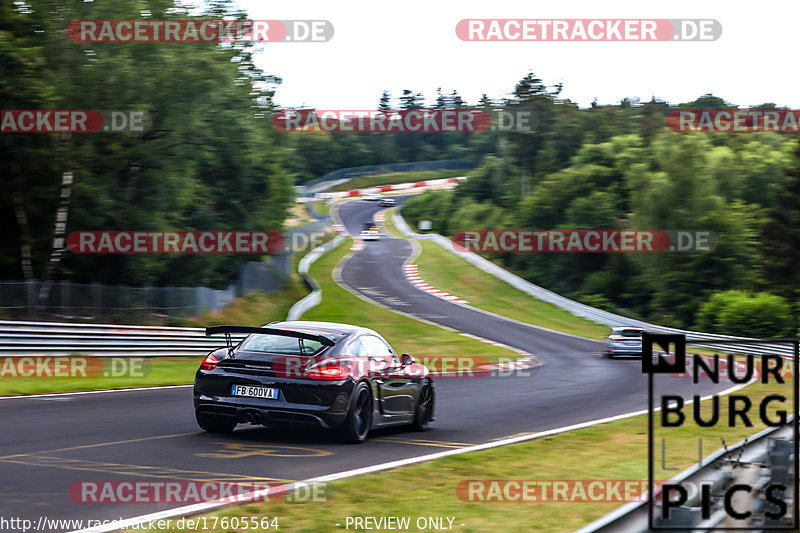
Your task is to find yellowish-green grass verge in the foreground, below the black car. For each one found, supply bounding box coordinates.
[155,372,786,533]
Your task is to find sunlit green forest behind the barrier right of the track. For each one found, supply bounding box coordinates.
[403,75,800,336]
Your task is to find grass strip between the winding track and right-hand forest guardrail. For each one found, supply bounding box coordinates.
[385,208,609,339]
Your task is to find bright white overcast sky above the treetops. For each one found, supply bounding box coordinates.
[227,0,800,109]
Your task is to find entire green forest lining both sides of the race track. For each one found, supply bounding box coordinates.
[0,0,800,335]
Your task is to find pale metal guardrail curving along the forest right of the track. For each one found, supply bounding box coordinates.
[393,210,792,357]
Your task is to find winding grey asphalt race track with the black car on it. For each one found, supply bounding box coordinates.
[0,200,730,531]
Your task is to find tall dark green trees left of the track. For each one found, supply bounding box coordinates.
[0,0,294,287]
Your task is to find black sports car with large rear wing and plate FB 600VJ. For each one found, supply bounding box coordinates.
[194,321,435,443]
